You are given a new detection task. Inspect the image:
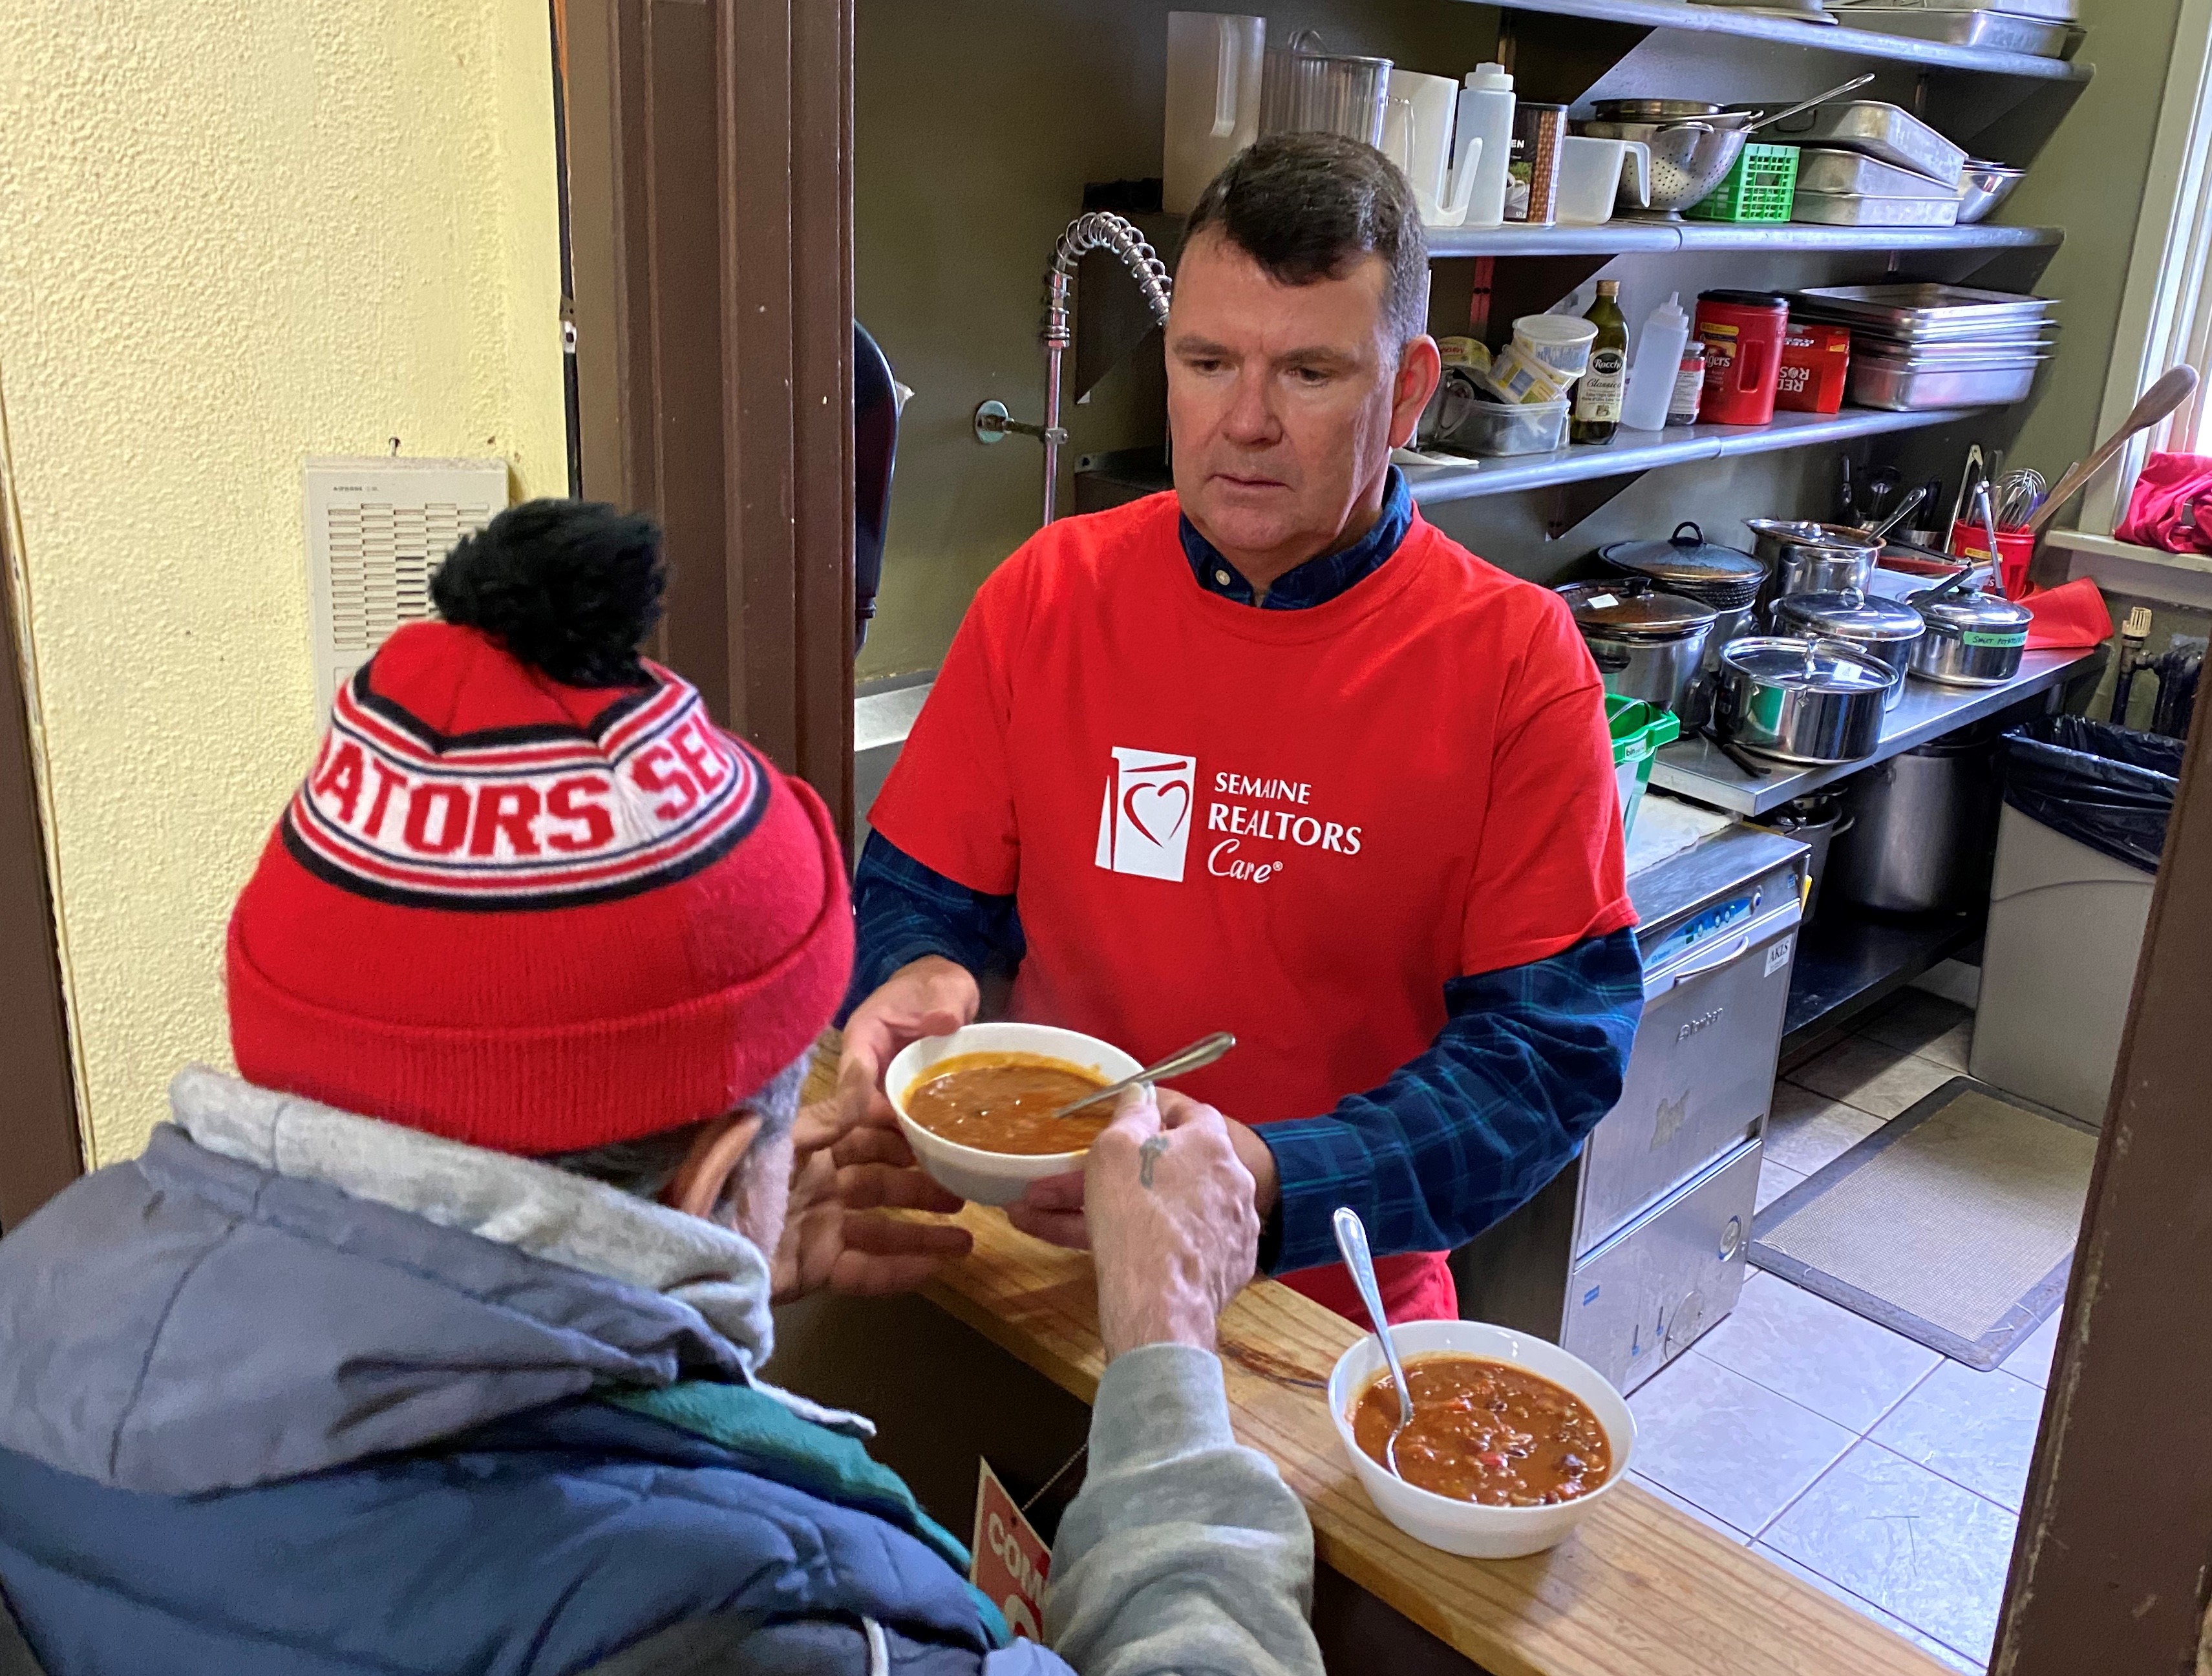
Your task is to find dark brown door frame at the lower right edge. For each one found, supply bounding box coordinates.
[1991,685,2212,1676]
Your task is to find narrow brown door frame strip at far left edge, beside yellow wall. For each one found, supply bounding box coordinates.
[0,502,84,1231]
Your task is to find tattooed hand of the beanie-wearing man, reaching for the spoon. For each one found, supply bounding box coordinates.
[1084,1088,1259,1362]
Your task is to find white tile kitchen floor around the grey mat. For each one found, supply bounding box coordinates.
[1628,991,2057,1676]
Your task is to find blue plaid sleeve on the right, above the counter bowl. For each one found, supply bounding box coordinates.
[1259,931,1644,1273]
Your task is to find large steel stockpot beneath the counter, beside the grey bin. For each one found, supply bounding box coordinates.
[1827,725,2002,913]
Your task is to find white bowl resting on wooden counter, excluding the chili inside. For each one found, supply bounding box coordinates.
[1330,1320,1637,1559]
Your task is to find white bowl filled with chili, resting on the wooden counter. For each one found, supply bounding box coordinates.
[1330,1320,1637,1559]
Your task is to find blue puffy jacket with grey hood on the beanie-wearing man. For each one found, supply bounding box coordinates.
[0,1128,1066,1676]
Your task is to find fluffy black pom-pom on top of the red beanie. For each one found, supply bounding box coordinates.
[429,500,668,688]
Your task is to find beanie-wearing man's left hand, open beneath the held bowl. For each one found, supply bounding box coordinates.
[774,1101,973,1304]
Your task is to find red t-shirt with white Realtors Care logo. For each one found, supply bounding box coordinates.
[869,493,1635,1320]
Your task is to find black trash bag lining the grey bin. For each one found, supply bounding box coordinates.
[2004,716,2181,873]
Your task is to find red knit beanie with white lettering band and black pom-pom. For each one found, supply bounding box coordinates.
[228,502,851,1154]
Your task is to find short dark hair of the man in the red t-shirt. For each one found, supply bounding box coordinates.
[1184,133,1429,347]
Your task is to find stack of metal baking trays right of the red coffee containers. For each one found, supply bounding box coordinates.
[1789,283,2057,411]
